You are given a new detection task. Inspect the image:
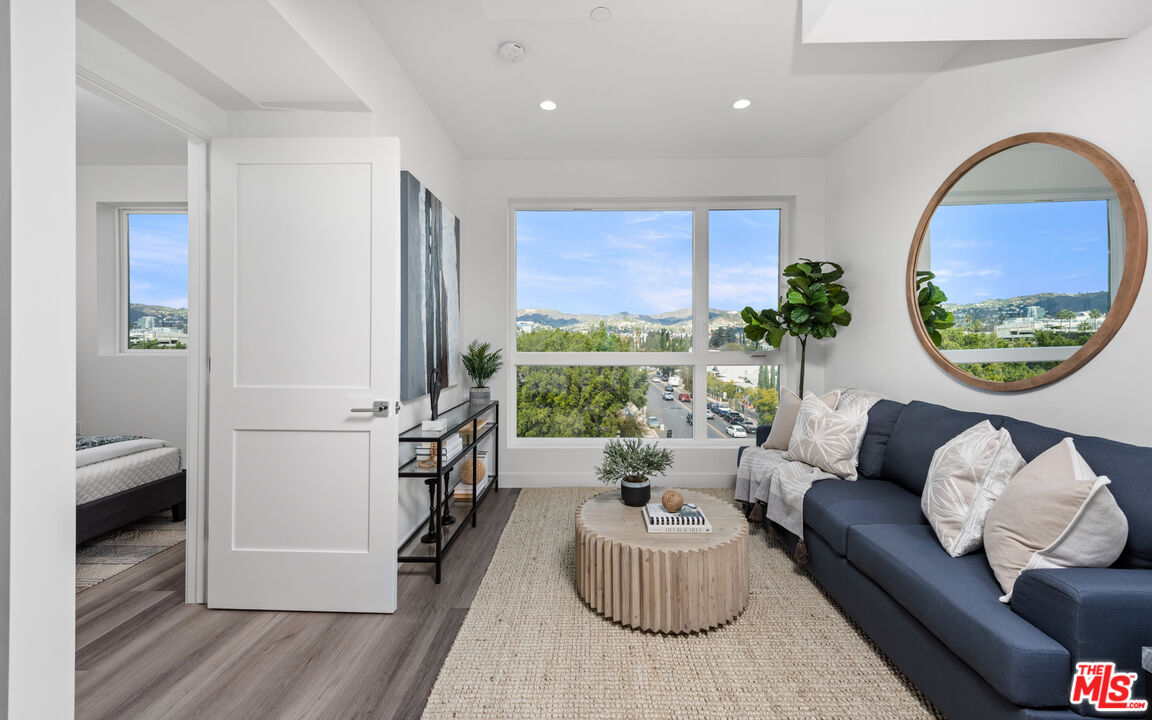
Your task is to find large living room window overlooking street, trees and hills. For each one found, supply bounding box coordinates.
[509,200,788,445]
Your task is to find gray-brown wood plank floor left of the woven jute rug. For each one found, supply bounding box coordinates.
[76,488,518,720]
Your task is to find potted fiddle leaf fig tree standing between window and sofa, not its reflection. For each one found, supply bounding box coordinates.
[740,258,852,397]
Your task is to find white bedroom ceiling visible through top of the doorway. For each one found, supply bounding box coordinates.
[76,88,188,165]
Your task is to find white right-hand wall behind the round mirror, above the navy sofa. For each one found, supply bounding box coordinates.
[826,30,1152,444]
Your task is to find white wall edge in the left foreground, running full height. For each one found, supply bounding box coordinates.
[0,0,76,719]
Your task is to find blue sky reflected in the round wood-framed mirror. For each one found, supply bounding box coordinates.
[930,200,1108,304]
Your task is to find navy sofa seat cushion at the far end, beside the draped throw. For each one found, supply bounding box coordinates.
[804,478,927,555]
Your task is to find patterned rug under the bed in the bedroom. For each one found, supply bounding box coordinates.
[76,510,184,593]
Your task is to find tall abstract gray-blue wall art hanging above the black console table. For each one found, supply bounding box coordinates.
[400,170,461,401]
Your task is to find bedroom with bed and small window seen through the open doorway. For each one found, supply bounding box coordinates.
[76,81,195,593]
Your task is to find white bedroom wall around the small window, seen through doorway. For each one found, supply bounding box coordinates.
[76,165,188,452]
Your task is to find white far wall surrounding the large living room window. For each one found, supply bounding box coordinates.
[461,158,825,486]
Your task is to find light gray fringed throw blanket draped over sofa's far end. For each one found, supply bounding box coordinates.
[735,387,884,563]
